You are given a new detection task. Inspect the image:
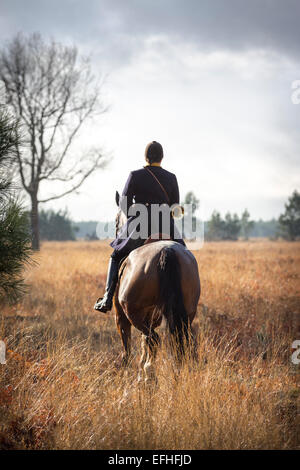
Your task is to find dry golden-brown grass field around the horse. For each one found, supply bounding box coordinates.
[0,241,300,449]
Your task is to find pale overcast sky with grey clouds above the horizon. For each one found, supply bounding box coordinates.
[0,0,300,220]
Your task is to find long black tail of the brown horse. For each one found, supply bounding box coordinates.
[157,247,189,354]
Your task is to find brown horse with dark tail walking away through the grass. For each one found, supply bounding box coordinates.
[114,193,201,382]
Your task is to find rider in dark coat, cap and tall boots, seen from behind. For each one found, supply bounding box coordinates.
[94,140,185,312]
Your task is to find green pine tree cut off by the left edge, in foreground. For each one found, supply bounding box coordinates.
[0,106,31,303]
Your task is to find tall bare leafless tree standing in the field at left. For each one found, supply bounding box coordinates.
[0,33,107,250]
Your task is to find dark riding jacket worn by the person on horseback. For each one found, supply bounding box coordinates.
[111,165,184,256]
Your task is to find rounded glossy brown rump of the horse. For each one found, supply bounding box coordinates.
[117,241,200,331]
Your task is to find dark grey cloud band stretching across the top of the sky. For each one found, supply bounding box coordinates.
[1,0,300,62]
